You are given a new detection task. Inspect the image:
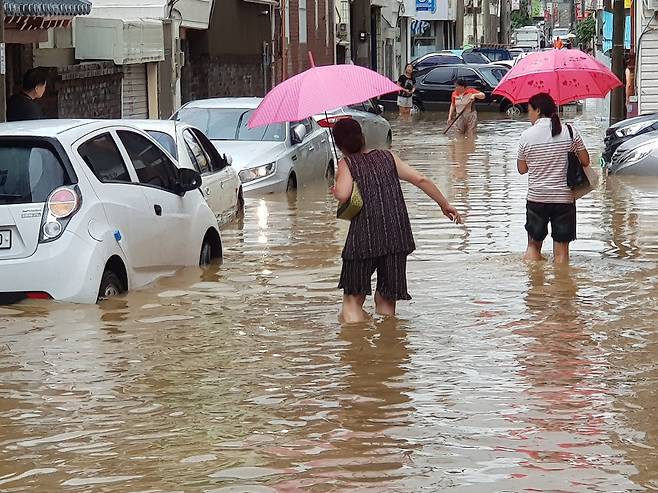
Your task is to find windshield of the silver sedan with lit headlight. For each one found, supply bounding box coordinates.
[176,108,286,142]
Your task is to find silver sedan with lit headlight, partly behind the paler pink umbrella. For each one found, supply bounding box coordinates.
[172,98,334,194]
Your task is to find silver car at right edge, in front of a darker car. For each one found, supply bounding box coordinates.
[606,131,658,176]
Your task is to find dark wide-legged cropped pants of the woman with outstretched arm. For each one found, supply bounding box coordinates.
[338,253,411,301]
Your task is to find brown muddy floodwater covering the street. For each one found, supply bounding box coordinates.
[0,108,658,493]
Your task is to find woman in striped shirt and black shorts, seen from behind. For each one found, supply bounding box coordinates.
[517,93,590,263]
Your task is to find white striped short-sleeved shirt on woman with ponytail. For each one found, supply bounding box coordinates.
[518,118,585,204]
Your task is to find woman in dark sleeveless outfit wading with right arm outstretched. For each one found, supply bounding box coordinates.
[332,119,463,323]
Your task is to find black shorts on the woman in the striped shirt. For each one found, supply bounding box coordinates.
[525,201,576,243]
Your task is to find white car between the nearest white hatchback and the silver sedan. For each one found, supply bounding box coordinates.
[125,120,244,226]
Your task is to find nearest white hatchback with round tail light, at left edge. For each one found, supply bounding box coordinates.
[0,120,222,303]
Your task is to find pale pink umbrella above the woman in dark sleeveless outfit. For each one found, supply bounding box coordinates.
[249,54,400,128]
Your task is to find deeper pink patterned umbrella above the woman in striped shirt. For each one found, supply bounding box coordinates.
[494,50,622,105]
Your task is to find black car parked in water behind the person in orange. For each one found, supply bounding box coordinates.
[382,64,525,114]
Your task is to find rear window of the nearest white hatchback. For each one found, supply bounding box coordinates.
[0,144,72,205]
